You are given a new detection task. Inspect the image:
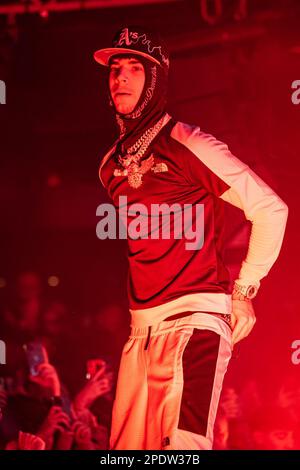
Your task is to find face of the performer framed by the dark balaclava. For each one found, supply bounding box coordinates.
[109,56,145,114]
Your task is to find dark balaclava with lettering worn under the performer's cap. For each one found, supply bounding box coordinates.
[109,53,168,155]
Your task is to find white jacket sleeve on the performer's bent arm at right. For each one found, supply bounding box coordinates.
[172,124,288,287]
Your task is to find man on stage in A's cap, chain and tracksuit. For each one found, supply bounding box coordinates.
[94,26,288,450]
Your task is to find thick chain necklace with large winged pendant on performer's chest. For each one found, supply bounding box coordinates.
[115,116,165,188]
